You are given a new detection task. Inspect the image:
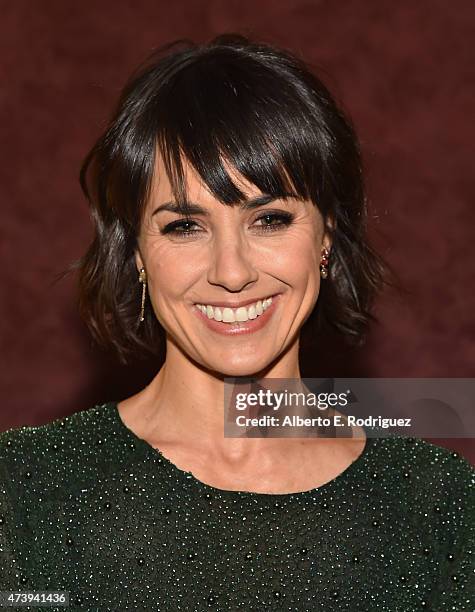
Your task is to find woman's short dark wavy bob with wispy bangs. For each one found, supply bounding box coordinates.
[71,33,398,363]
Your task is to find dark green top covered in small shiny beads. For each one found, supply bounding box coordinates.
[0,402,475,612]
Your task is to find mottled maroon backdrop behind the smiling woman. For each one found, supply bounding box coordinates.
[0,0,475,463]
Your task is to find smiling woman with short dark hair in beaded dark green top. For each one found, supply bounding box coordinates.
[0,35,475,612]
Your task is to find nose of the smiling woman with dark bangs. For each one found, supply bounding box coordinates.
[208,232,258,292]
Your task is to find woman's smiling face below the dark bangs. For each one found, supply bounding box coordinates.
[136,156,330,376]
